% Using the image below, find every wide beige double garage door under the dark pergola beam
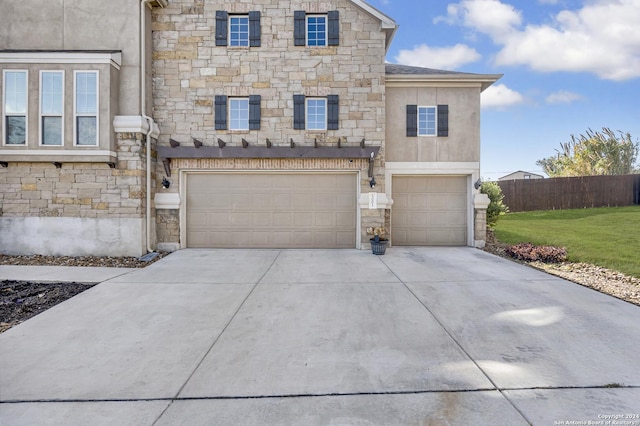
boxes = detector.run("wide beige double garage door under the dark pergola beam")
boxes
[186,173,357,248]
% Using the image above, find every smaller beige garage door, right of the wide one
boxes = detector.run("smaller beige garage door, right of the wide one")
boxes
[391,176,467,246]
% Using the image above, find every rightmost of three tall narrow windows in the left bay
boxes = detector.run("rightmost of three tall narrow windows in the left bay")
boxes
[74,71,98,146]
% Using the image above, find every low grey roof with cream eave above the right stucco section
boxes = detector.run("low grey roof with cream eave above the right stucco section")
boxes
[386,64,502,90]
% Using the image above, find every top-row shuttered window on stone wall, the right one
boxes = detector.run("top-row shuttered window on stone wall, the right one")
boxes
[293,10,340,47]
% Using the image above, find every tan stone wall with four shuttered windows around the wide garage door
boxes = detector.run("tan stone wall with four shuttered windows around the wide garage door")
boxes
[152,0,388,248]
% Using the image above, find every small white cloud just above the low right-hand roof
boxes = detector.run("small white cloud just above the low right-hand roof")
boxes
[395,44,481,70]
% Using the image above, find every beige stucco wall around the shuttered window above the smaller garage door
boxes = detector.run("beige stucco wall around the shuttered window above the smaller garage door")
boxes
[386,85,480,162]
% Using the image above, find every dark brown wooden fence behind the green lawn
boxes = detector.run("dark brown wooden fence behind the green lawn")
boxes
[498,175,640,212]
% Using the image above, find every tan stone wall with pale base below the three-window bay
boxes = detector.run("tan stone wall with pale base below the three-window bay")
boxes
[0,133,146,256]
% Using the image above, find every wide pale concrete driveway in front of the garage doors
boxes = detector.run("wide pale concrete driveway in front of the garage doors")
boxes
[0,247,640,426]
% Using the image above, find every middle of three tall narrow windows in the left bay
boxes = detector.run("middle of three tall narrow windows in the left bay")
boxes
[40,71,64,146]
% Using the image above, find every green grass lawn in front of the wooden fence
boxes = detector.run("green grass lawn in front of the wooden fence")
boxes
[495,206,640,278]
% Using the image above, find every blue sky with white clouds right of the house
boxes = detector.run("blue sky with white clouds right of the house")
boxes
[368,0,640,180]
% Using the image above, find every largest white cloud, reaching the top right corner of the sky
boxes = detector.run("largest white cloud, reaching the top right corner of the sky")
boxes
[441,0,640,81]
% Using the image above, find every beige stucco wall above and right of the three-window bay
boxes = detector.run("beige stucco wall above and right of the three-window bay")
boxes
[0,0,145,115]
